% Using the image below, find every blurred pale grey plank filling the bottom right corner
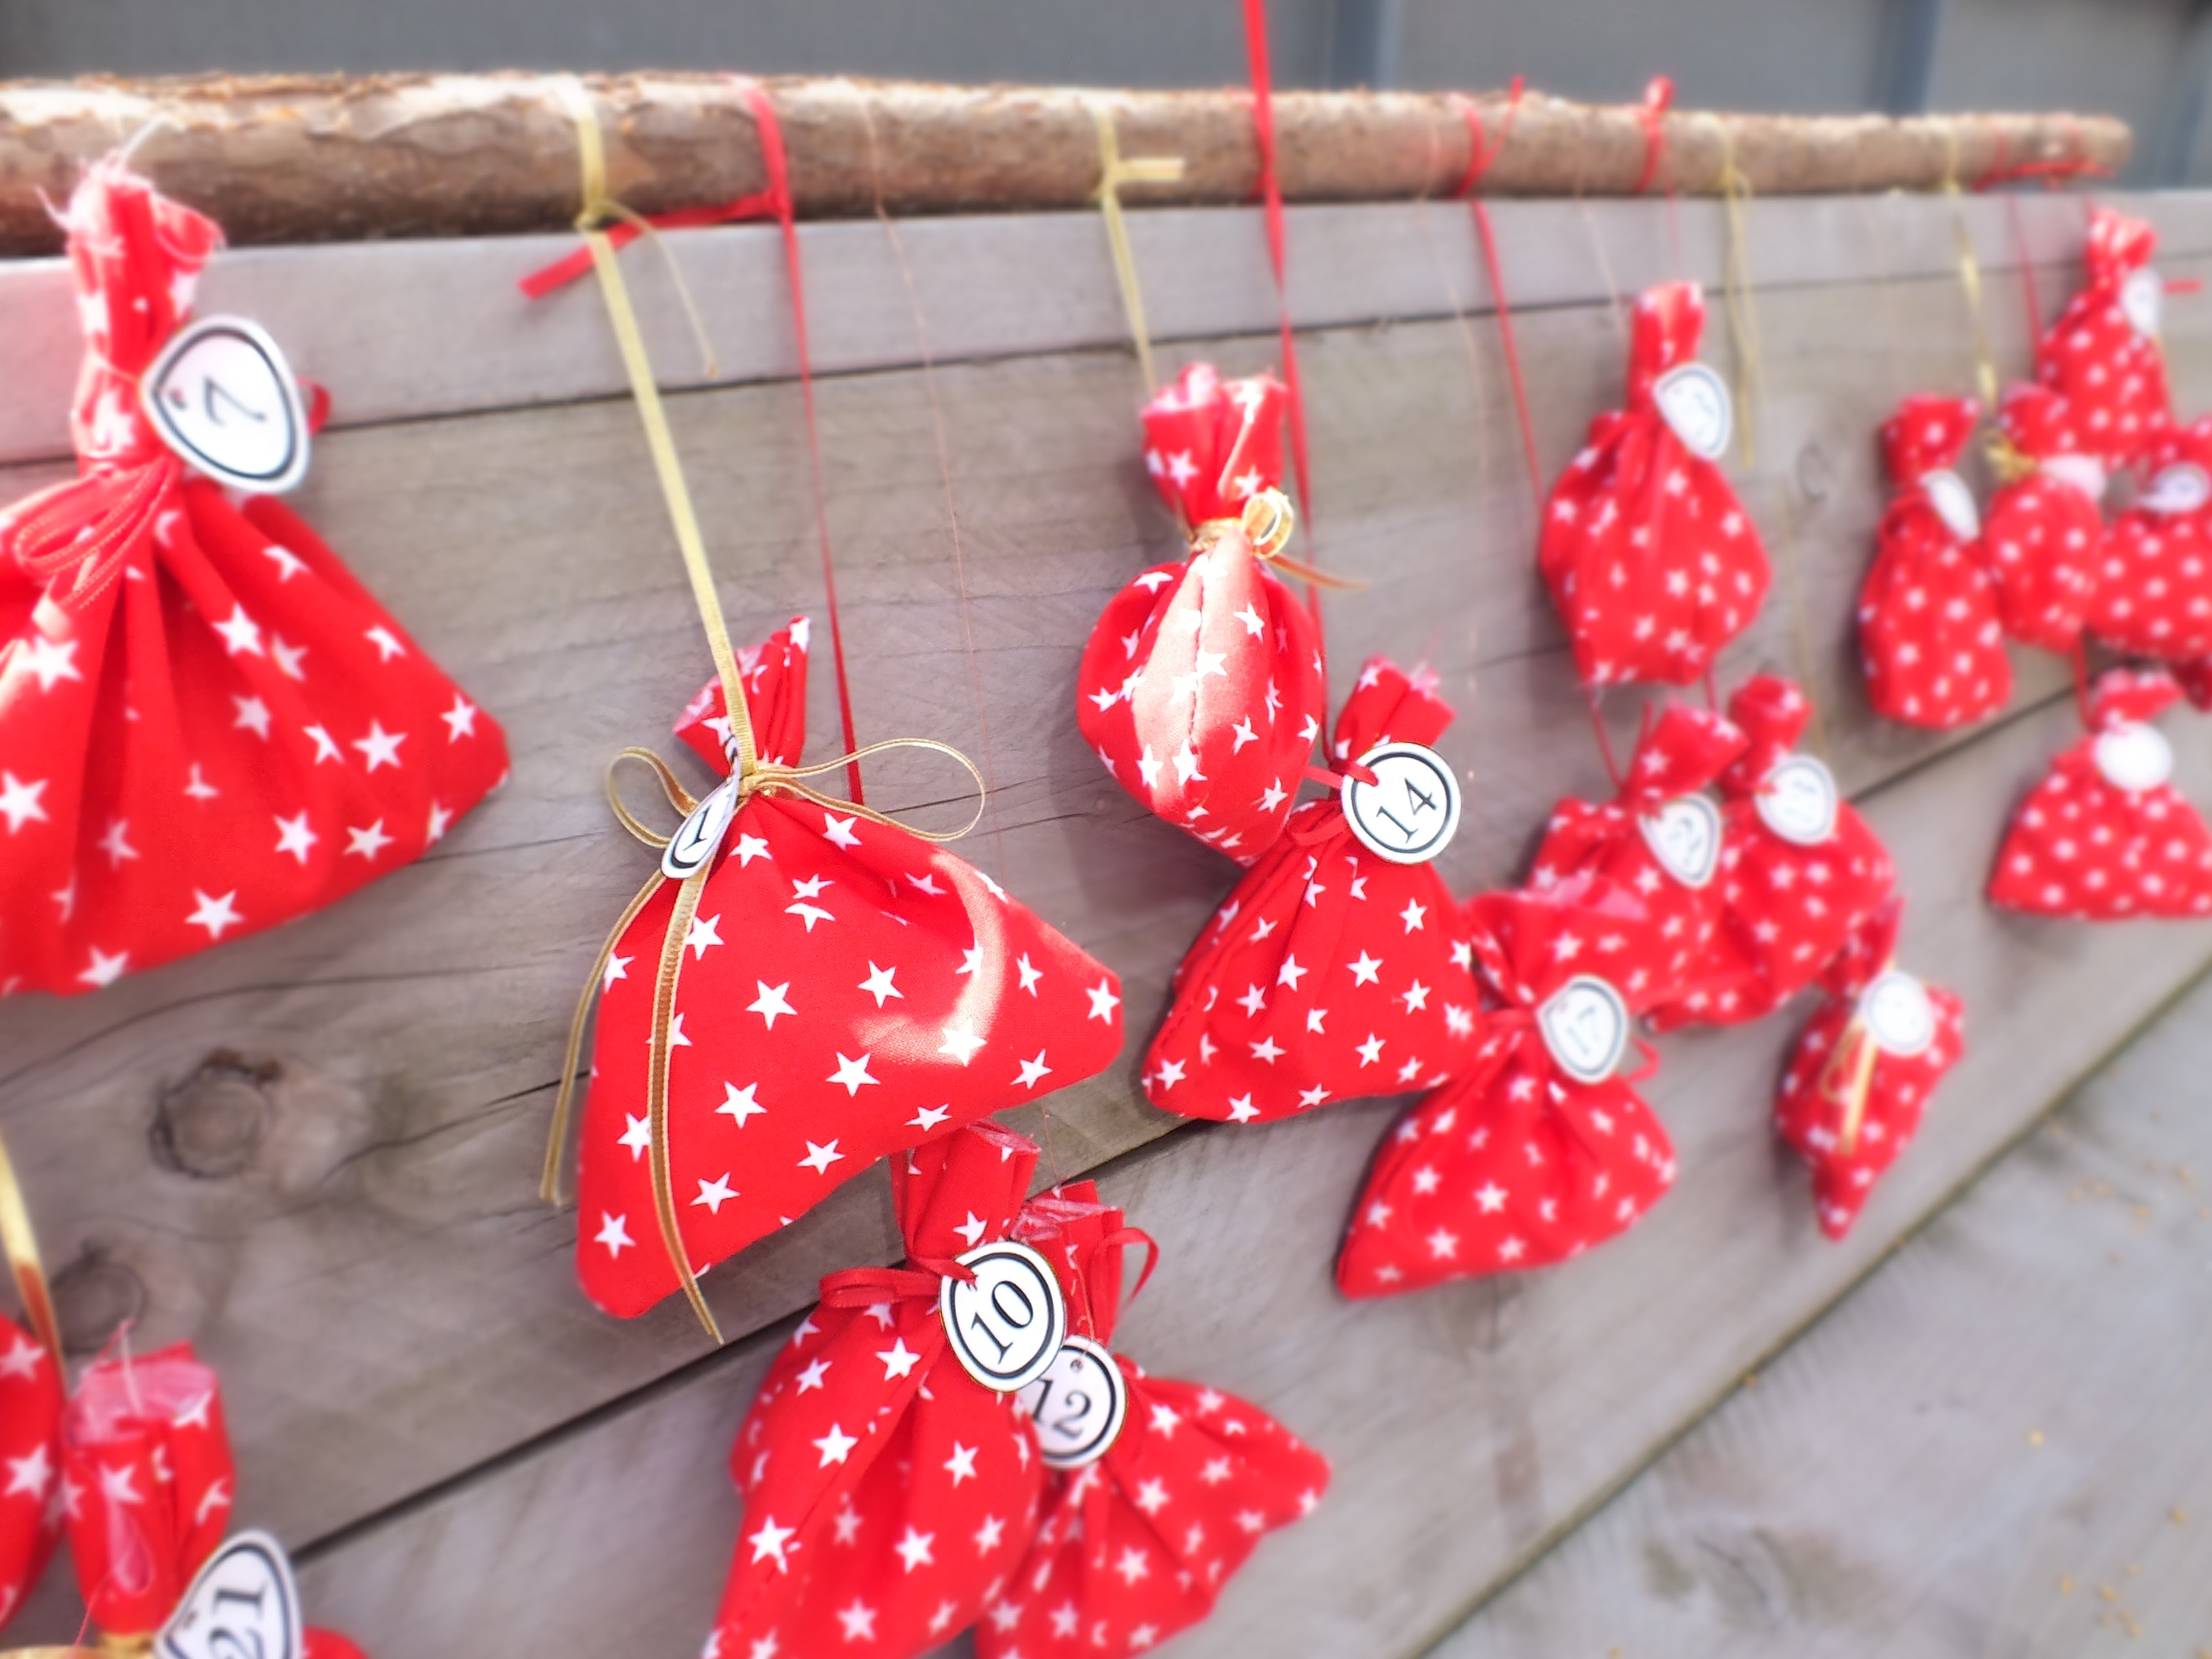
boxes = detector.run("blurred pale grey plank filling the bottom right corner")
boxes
[1435,982,2212,1659]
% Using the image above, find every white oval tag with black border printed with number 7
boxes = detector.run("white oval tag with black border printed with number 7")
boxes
[140,316,308,495]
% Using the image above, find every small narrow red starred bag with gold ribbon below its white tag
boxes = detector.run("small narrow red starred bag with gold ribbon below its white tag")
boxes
[1774,898,1964,1239]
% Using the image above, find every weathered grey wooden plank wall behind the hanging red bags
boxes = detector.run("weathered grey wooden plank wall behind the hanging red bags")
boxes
[13,194,2212,1659]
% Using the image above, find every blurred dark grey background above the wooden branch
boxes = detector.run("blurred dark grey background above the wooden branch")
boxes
[0,0,2212,184]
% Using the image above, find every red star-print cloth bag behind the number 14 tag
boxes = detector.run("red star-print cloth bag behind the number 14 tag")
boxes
[1143,657,1482,1124]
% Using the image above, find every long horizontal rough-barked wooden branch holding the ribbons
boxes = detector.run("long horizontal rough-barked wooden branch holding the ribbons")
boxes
[0,73,2132,254]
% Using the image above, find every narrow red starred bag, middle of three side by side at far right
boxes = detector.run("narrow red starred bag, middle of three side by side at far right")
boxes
[1982,385,2106,653]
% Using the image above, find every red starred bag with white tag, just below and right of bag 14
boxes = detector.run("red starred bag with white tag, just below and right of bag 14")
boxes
[1336,885,1675,1296]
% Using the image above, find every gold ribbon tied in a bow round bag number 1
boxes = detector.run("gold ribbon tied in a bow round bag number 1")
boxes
[539,75,987,1343]
